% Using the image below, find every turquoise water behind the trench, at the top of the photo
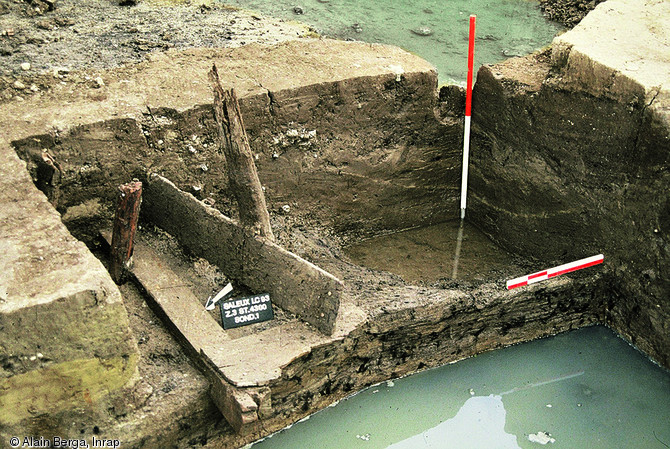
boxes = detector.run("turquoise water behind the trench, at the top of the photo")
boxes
[224,0,562,83]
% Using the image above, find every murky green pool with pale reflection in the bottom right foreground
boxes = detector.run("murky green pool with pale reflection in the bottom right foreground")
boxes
[252,326,670,449]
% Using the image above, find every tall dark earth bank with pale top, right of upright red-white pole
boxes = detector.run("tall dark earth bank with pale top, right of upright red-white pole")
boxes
[472,0,670,367]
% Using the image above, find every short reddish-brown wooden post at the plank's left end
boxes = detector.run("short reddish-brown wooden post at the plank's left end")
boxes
[110,181,142,283]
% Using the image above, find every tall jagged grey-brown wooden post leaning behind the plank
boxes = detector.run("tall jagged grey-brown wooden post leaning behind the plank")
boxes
[209,65,274,241]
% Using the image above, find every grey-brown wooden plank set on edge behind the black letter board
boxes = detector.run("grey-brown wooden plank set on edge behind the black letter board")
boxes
[143,174,344,335]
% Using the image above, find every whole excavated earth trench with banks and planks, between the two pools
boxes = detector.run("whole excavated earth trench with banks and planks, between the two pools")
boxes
[0,0,670,448]
